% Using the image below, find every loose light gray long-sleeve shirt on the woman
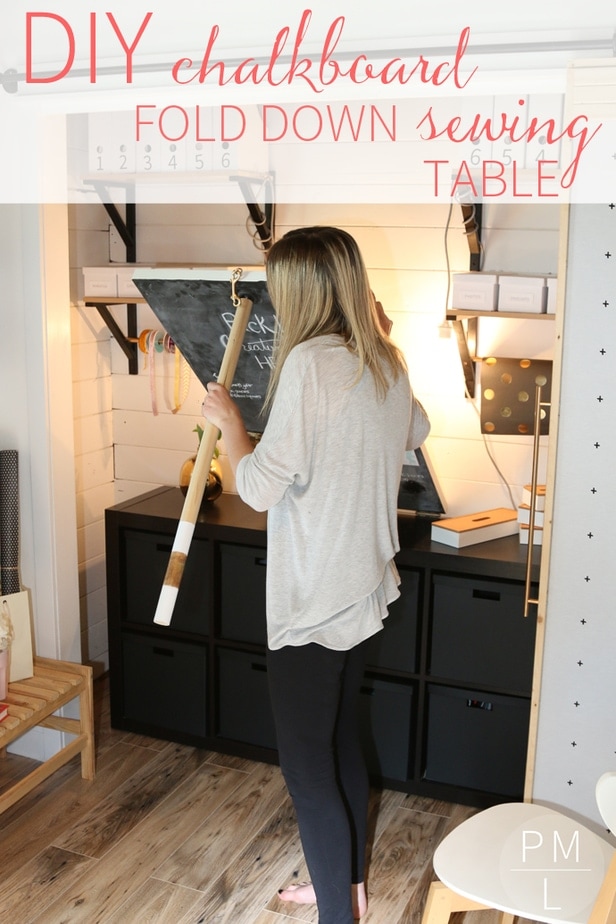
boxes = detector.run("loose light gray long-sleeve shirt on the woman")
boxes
[236,335,430,650]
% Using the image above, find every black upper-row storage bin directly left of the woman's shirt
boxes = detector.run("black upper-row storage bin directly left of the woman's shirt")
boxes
[220,542,267,645]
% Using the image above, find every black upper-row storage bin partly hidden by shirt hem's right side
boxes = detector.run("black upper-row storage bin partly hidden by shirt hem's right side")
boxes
[366,568,419,673]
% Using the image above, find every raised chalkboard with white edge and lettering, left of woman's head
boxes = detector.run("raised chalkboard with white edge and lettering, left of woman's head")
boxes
[133,267,276,433]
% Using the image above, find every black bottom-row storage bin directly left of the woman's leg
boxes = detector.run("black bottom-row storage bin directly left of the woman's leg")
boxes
[218,648,276,748]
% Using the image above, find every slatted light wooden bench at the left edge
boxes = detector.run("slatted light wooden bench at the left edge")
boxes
[0,657,95,814]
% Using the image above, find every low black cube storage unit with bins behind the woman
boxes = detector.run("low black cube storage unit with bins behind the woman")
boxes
[106,488,539,806]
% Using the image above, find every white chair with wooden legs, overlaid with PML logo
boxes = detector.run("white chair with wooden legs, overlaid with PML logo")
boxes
[422,772,616,924]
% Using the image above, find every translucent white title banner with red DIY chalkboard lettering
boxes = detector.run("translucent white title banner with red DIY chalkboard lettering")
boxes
[0,0,616,203]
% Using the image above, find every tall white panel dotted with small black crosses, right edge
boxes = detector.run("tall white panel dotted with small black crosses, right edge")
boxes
[533,200,616,821]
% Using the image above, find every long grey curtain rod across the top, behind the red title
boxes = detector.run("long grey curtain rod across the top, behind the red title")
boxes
[0,32,616,93]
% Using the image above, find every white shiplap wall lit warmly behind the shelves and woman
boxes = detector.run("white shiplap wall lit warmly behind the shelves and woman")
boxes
[71,204,559,664]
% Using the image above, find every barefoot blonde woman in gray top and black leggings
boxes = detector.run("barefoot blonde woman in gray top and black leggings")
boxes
[203,227,430,924]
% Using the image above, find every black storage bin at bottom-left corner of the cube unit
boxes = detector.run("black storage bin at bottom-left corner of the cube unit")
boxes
[122,633,207,738]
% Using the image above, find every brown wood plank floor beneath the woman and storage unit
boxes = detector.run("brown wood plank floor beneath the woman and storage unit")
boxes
[0,679,528,924]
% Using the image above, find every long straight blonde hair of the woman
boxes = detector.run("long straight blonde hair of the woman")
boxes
[265,226,406,406]
